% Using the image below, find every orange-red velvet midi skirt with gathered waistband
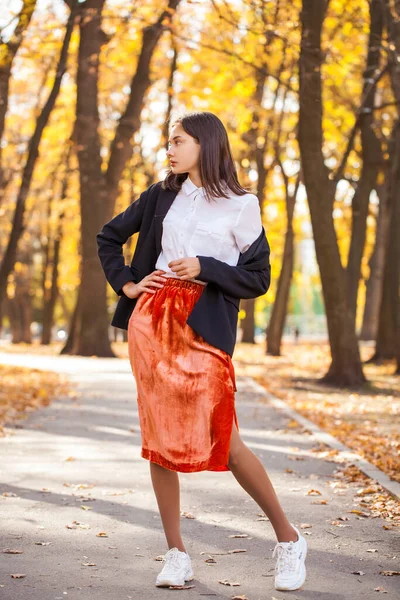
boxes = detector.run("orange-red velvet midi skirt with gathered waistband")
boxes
[128,277,239,473]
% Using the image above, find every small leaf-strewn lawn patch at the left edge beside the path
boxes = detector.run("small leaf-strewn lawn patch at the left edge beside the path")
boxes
[0,365,70,435]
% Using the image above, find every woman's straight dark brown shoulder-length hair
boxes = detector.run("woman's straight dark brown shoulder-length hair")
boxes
[162,111,249,199]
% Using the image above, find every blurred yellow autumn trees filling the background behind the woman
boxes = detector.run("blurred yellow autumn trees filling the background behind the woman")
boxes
[0,0,400,385]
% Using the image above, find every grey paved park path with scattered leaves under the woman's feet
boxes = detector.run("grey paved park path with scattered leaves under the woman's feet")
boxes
[0,353,400,600]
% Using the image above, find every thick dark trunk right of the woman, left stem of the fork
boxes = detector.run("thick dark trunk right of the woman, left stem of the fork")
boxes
[298,0,365,386]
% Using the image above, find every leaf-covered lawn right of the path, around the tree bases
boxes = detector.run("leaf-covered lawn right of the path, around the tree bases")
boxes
[234,342,400,482]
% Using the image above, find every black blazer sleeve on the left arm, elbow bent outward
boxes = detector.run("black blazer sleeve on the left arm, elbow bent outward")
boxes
[96,184,155,296]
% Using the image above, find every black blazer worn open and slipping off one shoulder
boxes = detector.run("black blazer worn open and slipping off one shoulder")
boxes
[96,181,271,356]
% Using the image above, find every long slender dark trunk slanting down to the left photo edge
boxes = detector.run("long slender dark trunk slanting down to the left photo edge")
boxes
[0,5,75,310]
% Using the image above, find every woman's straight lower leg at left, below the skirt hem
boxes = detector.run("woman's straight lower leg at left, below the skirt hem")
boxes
[150,461,186,552]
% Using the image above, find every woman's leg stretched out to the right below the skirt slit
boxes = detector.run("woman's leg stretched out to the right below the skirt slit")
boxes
[228,423,297,542]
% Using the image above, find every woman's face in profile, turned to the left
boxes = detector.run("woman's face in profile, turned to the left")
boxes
[167,123,200,174]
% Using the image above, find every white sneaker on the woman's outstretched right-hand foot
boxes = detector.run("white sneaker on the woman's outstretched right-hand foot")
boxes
[272,523,307,590]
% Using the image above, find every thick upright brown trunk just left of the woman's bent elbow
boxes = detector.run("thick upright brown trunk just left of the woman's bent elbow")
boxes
[70,0,114,356]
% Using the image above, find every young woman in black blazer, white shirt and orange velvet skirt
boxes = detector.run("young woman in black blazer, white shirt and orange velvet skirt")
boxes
[97,112,307,590]
